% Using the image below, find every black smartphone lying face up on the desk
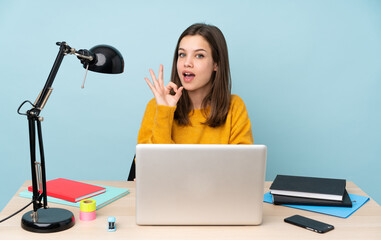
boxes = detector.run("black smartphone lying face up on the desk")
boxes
[284,215,334,233]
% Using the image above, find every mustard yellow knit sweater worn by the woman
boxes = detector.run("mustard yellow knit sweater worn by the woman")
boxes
[138,95,253,144]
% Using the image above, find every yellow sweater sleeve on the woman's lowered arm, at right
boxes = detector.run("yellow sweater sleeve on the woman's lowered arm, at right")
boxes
[229,96,254,144]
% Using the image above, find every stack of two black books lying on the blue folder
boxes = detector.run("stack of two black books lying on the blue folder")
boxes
[270,175,352,207]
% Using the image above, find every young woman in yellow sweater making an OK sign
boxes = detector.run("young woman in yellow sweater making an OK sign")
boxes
[138,24,253,144]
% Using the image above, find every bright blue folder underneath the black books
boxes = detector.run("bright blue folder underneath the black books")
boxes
[263,192,369,218]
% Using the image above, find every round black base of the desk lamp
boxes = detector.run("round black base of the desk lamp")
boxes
[21,208,75,233]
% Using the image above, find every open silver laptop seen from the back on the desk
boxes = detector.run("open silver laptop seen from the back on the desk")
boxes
[136,144,267,225]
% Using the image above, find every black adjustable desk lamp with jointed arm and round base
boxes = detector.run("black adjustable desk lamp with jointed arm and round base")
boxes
[17,42,124,233]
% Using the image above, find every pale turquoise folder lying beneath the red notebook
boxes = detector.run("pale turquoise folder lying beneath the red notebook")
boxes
[19,184,129,210]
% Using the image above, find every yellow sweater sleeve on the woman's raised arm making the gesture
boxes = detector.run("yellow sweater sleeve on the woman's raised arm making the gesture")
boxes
[138,99,176,144]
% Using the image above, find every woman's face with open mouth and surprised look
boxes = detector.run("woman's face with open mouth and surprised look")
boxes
[177,35,217,96]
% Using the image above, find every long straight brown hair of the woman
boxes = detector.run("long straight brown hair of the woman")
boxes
[171,23,231,127]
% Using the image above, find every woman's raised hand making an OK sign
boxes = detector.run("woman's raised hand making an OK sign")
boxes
[144,64,183,107]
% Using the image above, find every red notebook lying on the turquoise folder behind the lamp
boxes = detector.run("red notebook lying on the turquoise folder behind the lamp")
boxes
[28,178,106,202]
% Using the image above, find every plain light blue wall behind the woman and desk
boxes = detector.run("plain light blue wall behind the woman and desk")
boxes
[0,0,381,209]
